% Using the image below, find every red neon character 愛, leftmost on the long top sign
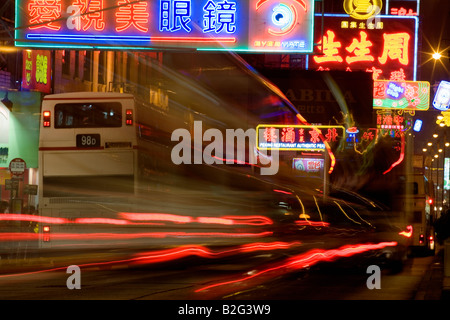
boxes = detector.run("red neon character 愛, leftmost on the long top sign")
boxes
[28,0,61,30]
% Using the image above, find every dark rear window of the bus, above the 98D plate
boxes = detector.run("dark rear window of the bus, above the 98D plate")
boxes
[55,102,122,128]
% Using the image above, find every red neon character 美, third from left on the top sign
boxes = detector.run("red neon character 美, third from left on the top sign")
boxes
[116,0,149,32]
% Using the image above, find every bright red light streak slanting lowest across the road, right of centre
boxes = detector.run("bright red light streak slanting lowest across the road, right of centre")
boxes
[195,241,397,292]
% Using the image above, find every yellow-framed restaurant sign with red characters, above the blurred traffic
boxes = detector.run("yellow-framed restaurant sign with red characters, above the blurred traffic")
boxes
[256,124,345,151]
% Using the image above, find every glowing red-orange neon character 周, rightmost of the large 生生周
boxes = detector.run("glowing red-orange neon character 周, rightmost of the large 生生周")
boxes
[378,32,411,65]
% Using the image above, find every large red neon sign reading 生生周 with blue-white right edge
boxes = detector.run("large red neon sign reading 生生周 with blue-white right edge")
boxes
[308,14,418,81]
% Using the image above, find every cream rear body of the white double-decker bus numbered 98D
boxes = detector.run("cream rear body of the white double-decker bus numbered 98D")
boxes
[39,92,137,248]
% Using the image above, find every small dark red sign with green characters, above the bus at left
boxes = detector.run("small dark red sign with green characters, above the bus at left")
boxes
[22,50,52,93]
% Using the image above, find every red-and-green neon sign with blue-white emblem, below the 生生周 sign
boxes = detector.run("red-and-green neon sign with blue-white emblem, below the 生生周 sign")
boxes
[373,80,430,111]
